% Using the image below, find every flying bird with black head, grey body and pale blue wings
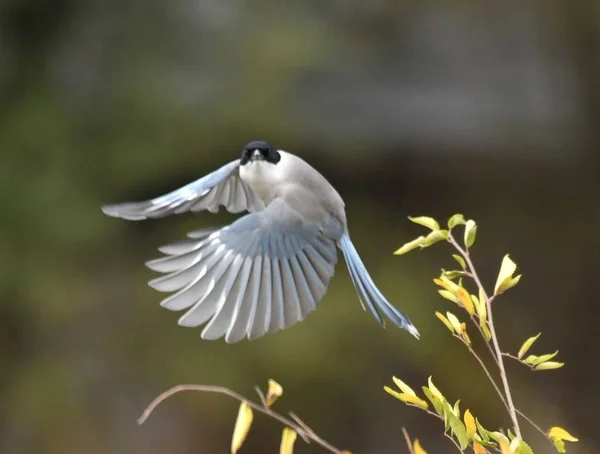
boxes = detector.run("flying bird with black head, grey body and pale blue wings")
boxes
[102,140,419,343]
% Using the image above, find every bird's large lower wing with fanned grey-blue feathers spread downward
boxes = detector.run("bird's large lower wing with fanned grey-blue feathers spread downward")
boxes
[147,200,337,343]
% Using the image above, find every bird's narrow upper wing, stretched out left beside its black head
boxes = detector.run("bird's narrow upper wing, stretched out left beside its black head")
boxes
[102,159,265,221]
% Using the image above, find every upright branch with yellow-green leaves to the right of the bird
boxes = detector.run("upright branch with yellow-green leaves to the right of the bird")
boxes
[384,214,578,454]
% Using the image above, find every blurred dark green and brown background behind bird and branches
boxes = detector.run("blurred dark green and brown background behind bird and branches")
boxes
[0,0,600,454]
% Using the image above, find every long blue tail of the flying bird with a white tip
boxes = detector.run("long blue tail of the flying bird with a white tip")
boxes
[339,233,419,339]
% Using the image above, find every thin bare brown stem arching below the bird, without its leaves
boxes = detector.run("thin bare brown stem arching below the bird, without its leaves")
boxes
[138,385,343,454]
